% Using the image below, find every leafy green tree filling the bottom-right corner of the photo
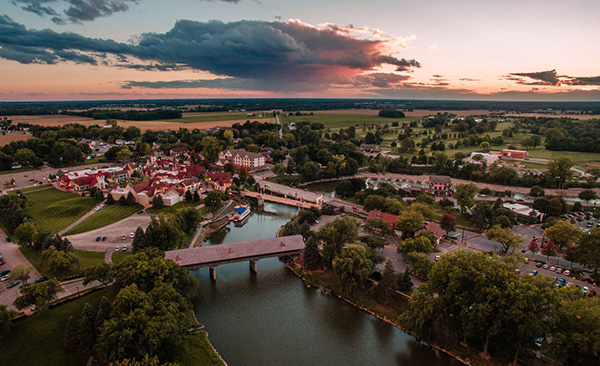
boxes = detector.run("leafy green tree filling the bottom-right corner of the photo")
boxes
[550,298,600,366]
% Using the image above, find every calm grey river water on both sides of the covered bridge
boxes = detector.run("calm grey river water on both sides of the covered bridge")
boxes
[192,203,461,366]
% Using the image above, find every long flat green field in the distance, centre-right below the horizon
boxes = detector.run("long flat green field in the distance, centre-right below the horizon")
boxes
[279,113,419,130]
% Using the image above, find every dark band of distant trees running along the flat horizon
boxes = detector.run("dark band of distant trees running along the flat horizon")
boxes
[0,98,600,116]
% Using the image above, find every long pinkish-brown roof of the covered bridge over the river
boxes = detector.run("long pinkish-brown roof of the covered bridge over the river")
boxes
[165,235,304,267]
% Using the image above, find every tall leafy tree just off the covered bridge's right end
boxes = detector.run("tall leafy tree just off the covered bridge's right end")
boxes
[317,216,358,268]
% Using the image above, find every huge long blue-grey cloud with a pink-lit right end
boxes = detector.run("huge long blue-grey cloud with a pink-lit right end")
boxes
[0,16,420,88]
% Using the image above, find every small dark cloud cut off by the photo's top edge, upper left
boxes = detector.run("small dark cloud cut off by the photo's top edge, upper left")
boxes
[12,0,138,24]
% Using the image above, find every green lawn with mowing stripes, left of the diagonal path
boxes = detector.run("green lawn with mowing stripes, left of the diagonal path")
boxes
[17,187,98,233]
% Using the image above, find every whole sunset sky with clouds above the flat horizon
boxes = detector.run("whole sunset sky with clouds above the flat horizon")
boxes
[0,0,600,101]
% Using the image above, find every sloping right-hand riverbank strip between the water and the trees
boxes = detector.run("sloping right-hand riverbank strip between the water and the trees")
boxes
[286,260,505,366]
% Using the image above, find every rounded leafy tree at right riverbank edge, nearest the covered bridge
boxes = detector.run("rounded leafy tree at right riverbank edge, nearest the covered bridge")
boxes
[333,244,373,296]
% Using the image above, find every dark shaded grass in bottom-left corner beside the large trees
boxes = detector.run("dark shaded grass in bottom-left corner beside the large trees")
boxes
[0,288,115,366]
